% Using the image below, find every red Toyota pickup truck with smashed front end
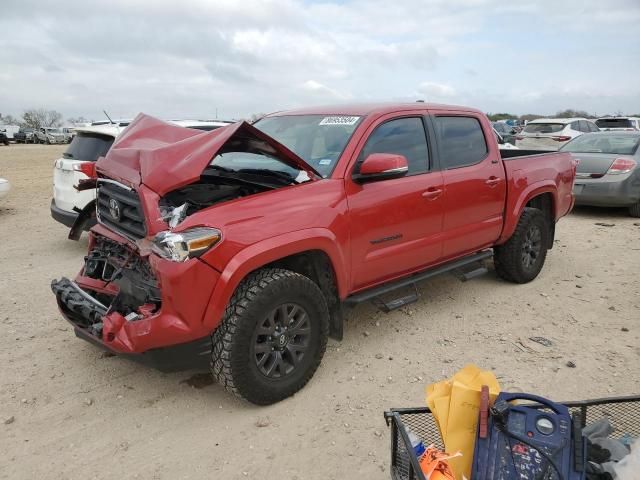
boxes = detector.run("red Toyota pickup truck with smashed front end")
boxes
[52,103,576,404]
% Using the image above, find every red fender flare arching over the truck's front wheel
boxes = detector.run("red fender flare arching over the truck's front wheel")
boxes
[203,228,349,331]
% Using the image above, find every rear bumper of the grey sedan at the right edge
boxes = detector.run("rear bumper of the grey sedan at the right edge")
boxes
[573,175,640,207]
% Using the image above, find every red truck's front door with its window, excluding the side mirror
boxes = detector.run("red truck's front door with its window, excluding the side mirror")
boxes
[345,113,443,290]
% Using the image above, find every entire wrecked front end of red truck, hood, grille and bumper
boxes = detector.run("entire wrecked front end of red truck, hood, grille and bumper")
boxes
[51,115,321,370]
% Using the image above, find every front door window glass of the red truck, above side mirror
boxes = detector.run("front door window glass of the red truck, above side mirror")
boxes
[356,117,429,175]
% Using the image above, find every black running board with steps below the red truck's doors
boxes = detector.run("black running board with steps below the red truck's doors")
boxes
[344,250,493,311]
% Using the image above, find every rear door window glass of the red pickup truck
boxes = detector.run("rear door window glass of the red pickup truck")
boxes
[434,117,489,169]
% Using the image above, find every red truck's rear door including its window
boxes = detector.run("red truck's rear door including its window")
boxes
[431,111,506,259]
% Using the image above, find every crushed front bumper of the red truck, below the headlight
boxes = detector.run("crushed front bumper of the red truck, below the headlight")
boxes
[51,226,219,371]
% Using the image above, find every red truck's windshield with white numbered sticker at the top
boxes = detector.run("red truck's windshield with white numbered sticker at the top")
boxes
[253,115,362,178]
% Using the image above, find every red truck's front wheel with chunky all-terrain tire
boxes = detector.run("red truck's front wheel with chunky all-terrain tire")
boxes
[211,268,329,405]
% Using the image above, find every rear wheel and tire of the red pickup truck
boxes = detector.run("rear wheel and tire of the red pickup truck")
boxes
[493,208,549,283]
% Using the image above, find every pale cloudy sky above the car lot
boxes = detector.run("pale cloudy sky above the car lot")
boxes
[0,0,640,118]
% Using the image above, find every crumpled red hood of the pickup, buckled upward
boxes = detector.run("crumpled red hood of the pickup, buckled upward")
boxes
[96,113,321,195]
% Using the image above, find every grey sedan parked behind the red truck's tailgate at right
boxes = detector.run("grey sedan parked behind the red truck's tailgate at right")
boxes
[560,131,640,217]
